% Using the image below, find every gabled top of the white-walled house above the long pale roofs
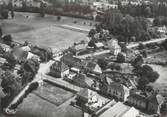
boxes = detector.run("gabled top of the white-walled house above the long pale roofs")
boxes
[77,88,96,99]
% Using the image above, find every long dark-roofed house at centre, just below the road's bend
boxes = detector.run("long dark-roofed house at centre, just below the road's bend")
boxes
[60,54,85,69]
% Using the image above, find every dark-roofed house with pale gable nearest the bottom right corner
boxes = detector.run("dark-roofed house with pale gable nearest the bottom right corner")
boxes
[148,94,164,114]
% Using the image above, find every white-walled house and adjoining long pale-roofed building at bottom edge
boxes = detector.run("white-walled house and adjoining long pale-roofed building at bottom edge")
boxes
[75,89,145,117]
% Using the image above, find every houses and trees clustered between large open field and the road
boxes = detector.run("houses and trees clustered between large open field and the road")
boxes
[68,31,121,56]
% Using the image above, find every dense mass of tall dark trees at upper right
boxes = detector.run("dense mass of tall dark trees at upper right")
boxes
[97,9,151,42]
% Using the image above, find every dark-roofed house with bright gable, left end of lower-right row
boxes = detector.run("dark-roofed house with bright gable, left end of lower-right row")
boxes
[107,82,129,101]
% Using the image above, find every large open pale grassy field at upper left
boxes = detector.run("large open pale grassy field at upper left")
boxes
[0,13,95,49]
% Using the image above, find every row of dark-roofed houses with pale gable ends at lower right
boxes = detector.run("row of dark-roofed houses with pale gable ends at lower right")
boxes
[101,82,165,114]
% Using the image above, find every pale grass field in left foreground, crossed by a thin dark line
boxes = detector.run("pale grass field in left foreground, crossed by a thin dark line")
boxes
[11,84,82,117]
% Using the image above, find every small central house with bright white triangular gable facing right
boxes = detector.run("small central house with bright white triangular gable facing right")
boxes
[85,62,102,74]
